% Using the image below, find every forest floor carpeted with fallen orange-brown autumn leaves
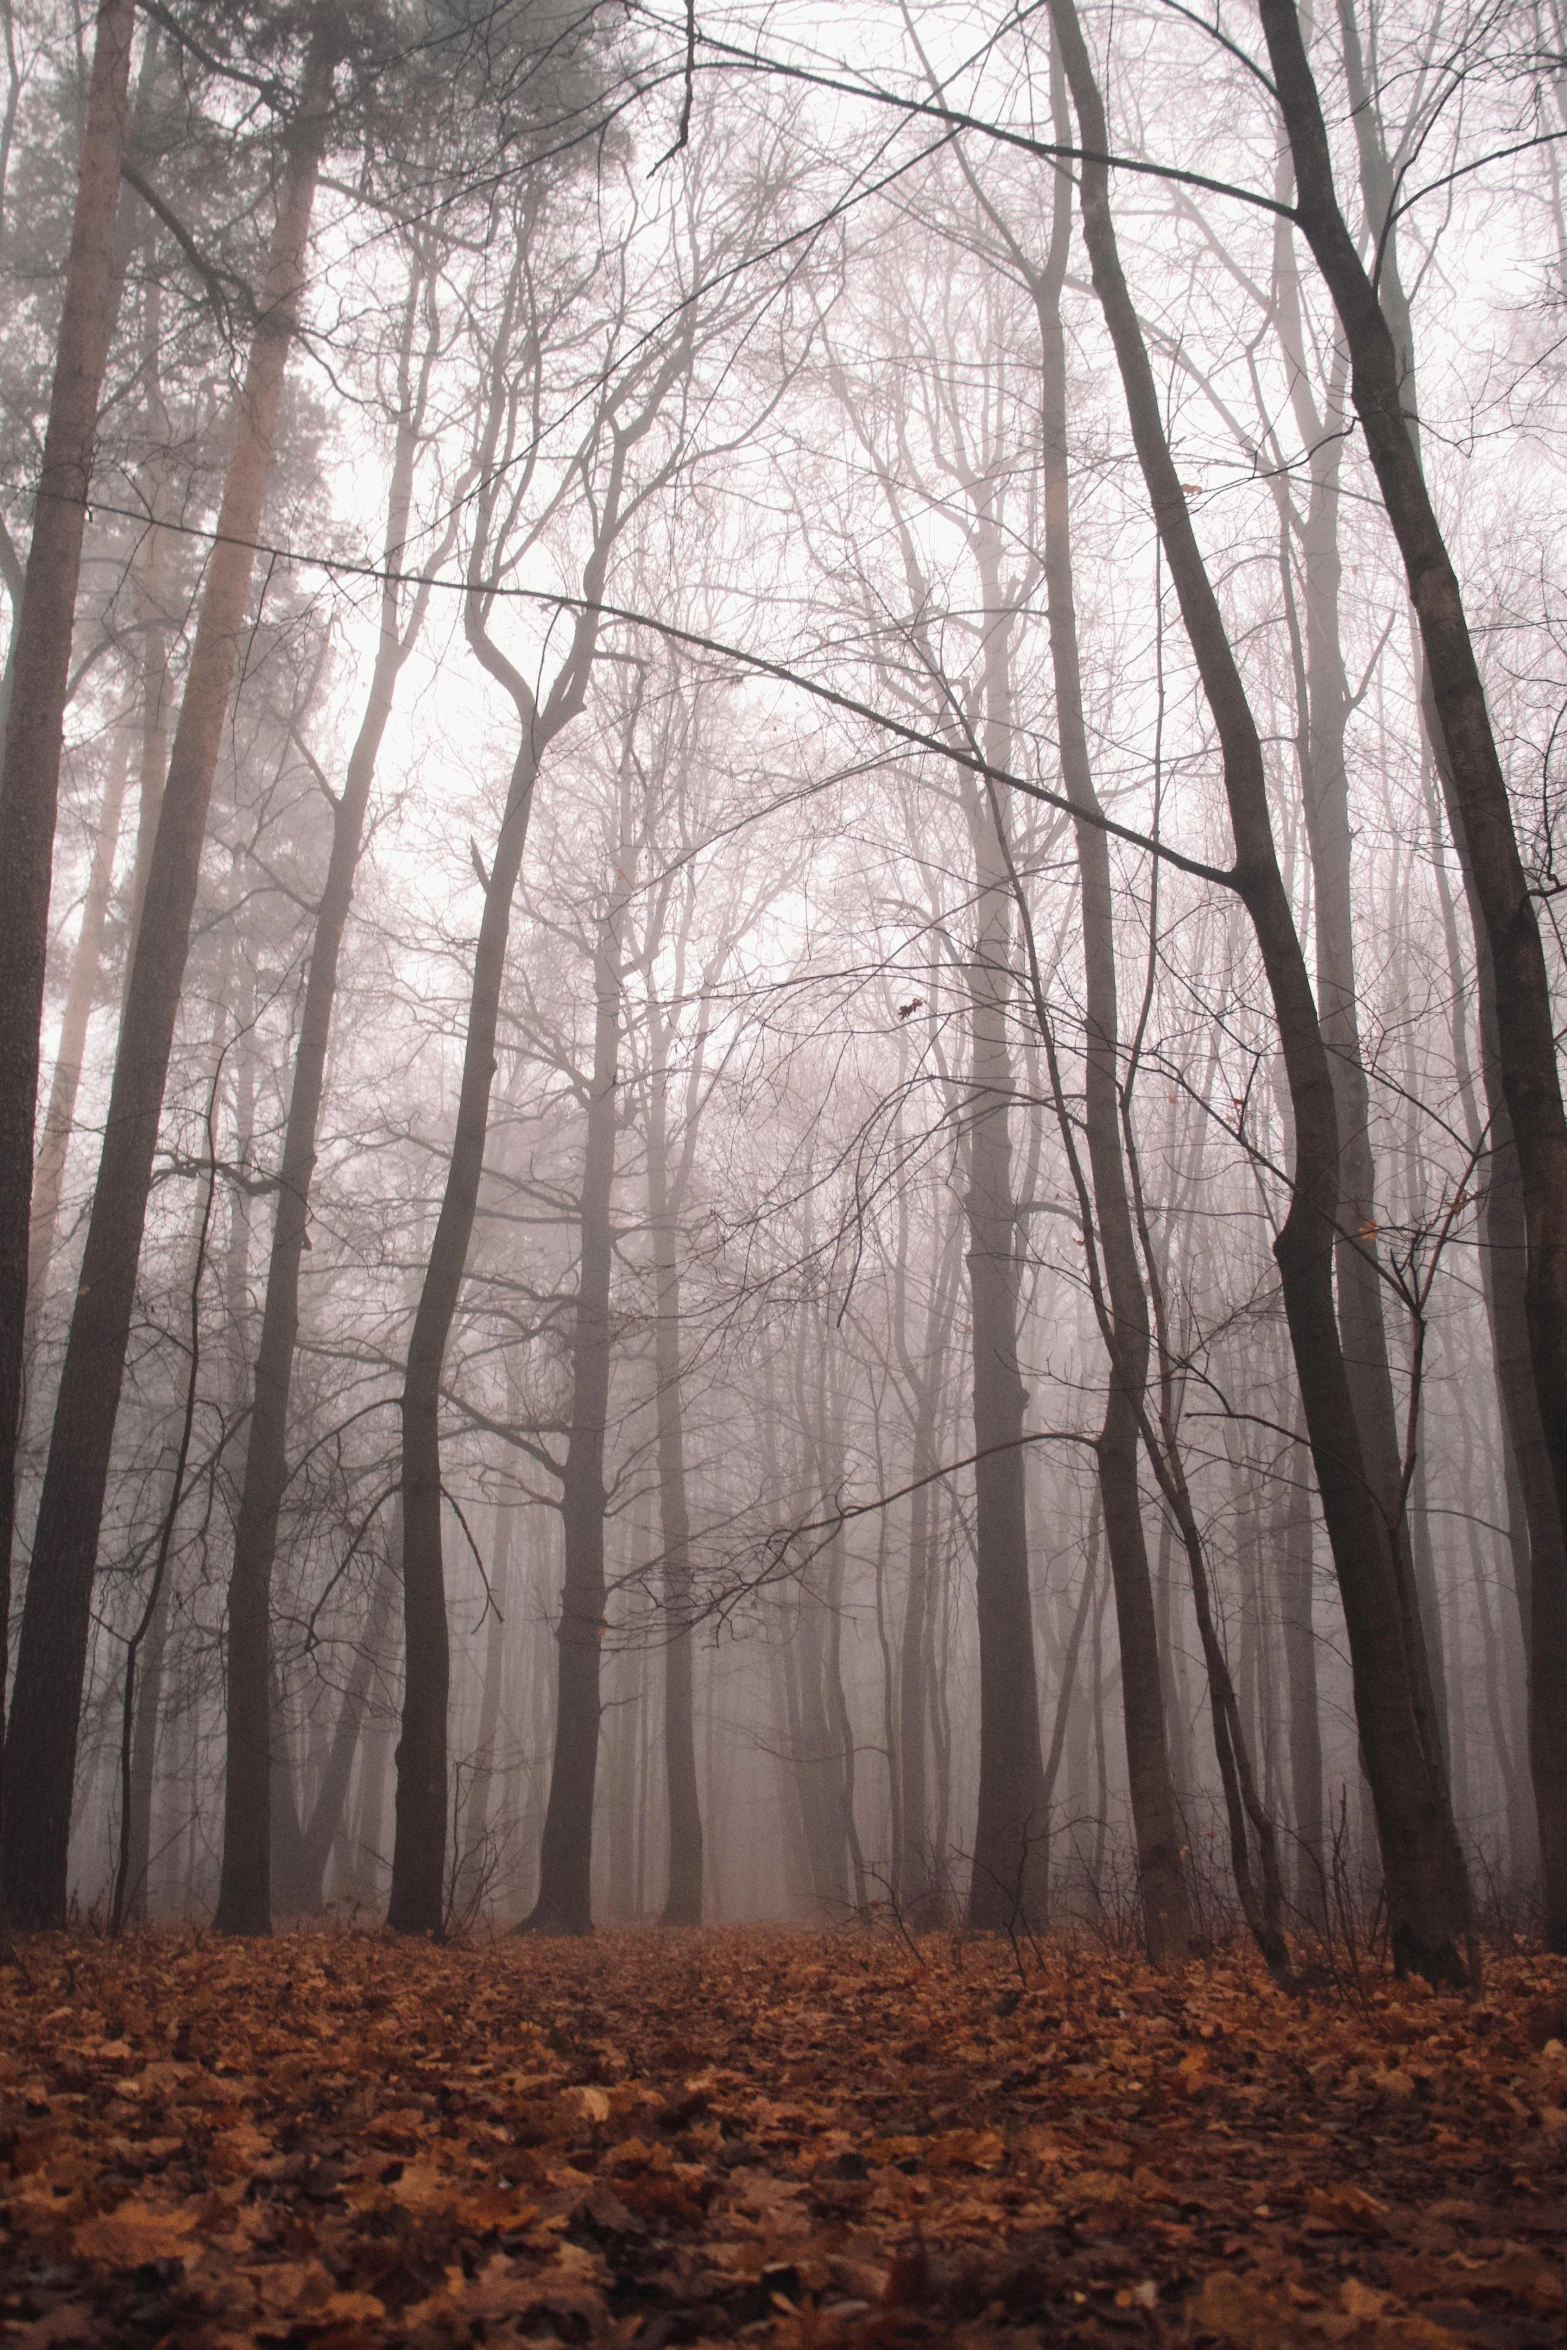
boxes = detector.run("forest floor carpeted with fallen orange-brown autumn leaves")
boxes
[0,1927,1567,2350]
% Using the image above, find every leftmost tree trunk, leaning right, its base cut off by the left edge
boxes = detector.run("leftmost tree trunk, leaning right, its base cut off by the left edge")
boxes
[0,0,136,1776]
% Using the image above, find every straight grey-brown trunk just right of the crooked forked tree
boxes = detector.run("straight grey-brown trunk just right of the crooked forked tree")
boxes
[524,845,632,1934]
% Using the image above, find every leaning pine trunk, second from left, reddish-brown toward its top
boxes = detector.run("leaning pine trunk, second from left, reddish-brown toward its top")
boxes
[5,32,341,1927]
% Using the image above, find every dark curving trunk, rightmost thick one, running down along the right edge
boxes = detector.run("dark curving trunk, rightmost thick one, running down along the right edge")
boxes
[1259,0,1567,1951]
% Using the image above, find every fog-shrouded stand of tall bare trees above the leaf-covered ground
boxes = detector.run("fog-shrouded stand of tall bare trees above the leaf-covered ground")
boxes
[0,0,1567,1981]
